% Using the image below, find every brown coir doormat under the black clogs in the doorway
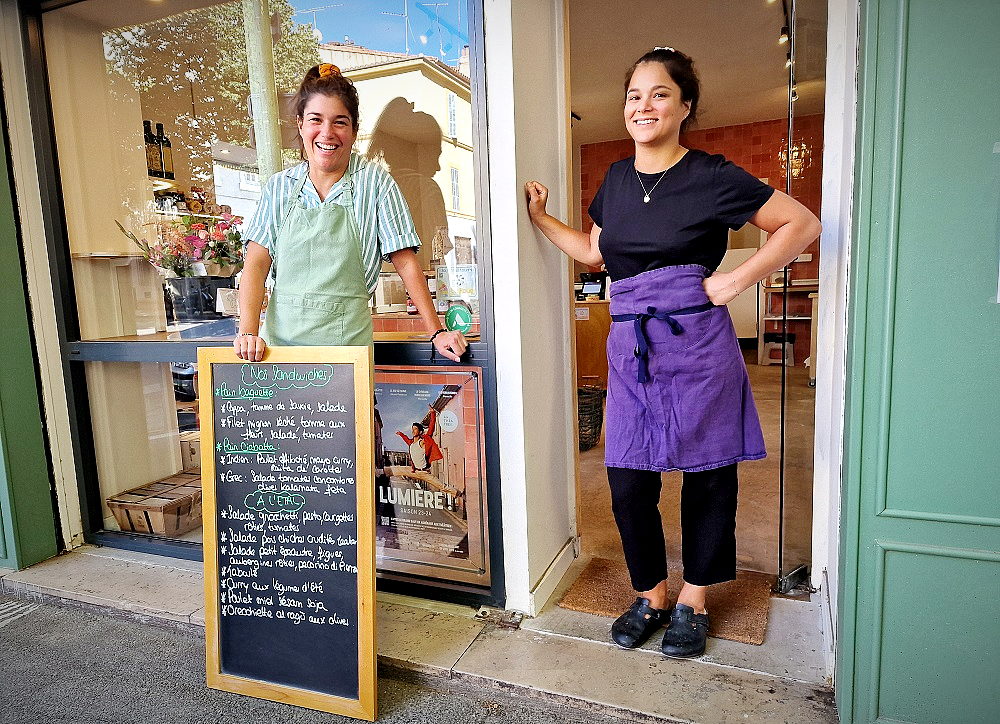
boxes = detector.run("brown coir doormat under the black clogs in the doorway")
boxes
[559,558,775,646]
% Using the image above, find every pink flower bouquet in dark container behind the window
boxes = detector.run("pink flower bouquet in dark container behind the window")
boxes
[115,214,243,321]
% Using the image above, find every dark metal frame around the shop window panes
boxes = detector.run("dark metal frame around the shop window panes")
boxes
[21,0,506,607]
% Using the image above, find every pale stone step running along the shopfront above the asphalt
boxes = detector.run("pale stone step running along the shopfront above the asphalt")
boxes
[0,546,837,724]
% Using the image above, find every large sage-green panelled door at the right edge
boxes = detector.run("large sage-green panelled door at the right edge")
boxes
[837,0,1000,724]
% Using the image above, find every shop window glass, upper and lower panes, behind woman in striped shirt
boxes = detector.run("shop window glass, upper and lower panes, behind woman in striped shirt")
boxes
[43,0,482,552]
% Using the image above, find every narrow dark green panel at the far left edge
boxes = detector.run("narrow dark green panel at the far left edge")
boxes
[0,79,61,569]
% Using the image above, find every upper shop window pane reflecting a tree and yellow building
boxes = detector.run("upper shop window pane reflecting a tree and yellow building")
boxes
[57,0,482,346]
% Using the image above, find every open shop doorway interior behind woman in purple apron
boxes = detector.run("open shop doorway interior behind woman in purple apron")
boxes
[569,0,827,680]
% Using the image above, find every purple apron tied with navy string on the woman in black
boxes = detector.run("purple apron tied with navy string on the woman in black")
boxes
[605,264,766,472]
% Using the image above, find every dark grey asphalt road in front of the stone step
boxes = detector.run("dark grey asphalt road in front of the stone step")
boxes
[0,595,636,724]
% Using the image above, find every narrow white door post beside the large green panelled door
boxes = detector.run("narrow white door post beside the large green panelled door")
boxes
[812,0,858,672]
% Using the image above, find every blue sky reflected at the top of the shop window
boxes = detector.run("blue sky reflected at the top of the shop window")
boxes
[290,0,469,65]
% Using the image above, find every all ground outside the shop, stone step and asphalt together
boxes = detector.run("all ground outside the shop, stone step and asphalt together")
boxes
[0,546,838,724]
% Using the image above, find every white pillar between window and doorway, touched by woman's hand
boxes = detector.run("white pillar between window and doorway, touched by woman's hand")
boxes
[484,0,576,614]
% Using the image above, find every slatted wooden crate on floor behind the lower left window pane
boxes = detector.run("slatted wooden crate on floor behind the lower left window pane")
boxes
[108,470,201,536]
